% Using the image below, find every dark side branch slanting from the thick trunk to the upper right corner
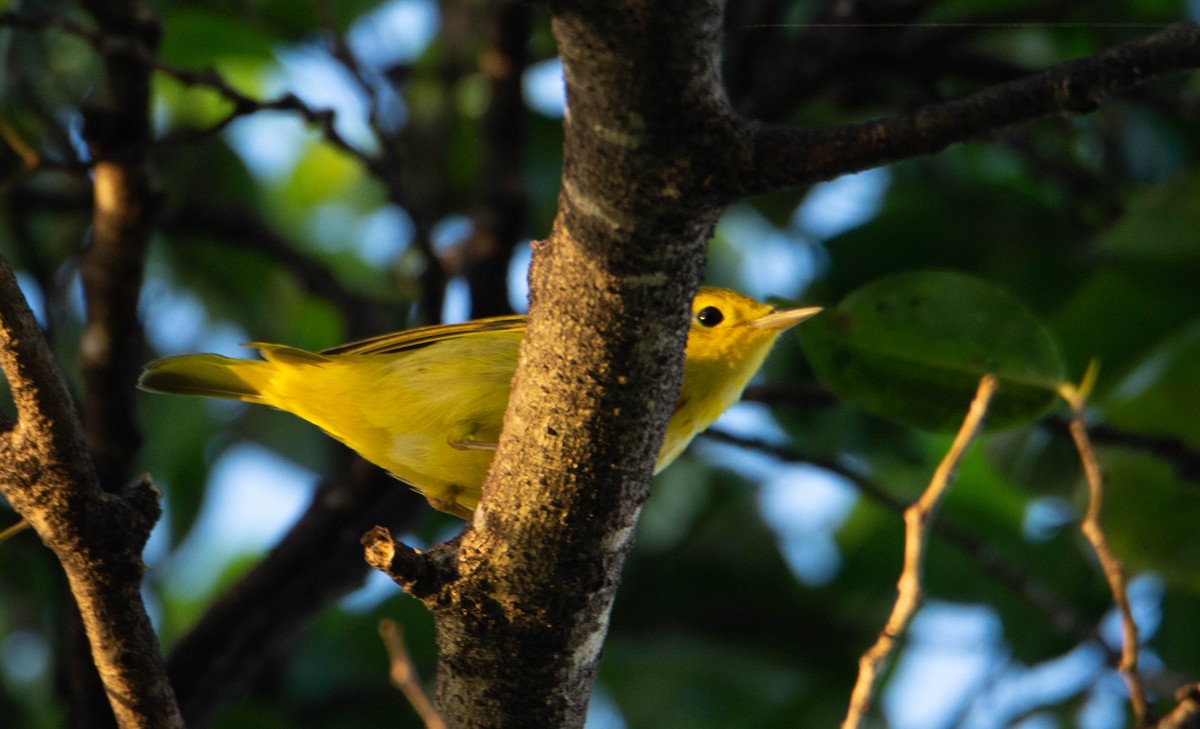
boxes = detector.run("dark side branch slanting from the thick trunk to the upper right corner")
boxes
[727,23,1200,198]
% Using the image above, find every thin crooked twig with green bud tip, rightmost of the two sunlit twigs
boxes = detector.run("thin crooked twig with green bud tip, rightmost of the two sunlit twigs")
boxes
[1062,378,1148,727]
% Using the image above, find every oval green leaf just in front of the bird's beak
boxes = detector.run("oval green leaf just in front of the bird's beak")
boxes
[800,271,1063,430]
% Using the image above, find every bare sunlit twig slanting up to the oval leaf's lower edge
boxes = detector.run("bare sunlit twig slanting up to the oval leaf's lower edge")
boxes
[841,374,996,729]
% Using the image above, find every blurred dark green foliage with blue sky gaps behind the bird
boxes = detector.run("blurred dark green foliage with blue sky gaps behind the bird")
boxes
[0,0,1200,729]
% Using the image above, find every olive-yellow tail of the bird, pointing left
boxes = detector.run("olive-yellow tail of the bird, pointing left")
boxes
[138,355,275,403]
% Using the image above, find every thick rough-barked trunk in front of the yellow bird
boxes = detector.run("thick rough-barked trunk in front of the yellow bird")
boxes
[415,0,737,727]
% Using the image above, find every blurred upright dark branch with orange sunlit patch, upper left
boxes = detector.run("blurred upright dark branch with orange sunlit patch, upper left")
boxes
[80,0,161,492]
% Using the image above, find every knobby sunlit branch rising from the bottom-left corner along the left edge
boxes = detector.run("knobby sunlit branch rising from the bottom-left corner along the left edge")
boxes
[0,255,184,729]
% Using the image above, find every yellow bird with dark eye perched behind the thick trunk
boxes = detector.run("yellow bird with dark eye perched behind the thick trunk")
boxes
[138,287,821,518]
